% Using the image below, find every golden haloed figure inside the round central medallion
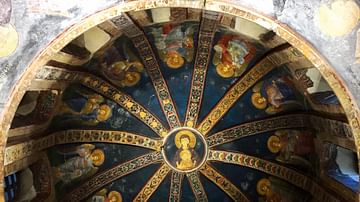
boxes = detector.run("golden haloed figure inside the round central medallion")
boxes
[175,130,197,170]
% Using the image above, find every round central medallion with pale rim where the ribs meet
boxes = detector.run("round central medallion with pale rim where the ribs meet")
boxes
[162,127,208,172]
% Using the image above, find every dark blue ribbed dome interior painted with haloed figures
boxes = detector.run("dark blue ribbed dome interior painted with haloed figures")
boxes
[9,7,358,201]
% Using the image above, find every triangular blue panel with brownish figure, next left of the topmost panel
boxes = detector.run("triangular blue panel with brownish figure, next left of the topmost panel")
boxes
[85,36,166,122]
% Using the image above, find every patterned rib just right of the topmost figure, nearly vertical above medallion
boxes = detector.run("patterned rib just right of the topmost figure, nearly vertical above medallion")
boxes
[184,11,221,127]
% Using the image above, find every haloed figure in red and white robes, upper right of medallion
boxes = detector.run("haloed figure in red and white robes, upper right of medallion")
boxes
[213,34,256,78]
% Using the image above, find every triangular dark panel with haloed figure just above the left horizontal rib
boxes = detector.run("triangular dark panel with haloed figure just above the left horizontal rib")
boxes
[51,85,161,137]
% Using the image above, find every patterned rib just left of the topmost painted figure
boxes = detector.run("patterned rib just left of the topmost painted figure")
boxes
[112,13,181,128]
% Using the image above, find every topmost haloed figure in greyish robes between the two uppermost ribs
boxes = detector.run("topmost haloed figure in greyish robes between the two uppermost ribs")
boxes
[151,24,195,69]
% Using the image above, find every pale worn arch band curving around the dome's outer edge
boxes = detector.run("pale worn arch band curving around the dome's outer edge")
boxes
[0,0,360,201]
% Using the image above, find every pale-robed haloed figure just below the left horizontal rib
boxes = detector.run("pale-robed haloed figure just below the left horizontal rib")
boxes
[53,144,105,184]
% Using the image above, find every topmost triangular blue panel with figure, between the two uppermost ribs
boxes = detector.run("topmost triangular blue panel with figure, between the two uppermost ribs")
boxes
[144,21,199,120]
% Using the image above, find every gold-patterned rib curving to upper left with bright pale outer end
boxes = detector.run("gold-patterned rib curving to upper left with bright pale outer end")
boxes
[36,66,168,137]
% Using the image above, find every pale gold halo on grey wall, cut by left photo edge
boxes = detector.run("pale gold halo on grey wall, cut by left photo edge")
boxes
[0,24,19,57]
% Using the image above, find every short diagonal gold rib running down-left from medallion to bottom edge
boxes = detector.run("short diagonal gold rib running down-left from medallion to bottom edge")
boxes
[133,164,170,202]
